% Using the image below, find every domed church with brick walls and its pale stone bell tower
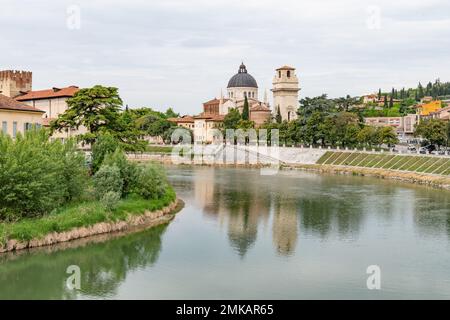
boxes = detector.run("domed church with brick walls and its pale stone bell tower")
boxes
[169,63,300,142]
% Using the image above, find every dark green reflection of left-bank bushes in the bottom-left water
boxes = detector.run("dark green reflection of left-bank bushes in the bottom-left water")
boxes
[0,225,167,299]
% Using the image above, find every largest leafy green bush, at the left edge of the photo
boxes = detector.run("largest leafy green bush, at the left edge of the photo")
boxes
[0,129,87,220]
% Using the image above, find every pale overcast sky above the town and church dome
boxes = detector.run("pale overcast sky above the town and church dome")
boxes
[0,0,450,114]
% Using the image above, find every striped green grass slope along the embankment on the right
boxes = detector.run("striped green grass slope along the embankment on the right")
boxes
[317,151,450,175]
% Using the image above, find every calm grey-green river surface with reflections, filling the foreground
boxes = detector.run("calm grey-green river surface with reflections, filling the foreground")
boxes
[0,167,450,299]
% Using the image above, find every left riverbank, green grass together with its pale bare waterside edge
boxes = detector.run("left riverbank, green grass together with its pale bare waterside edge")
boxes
[0,190,184,253]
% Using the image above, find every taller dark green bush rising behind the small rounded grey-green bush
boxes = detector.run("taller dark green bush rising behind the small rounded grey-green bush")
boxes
[102,148,138,197]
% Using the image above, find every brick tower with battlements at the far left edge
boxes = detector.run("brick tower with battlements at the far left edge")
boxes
[0,70,32,98]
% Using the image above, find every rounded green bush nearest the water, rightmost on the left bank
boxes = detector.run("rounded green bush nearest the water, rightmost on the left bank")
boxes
[133,163,170,199]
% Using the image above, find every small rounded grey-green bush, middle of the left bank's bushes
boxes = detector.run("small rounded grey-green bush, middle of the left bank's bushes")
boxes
[94,165,123,200]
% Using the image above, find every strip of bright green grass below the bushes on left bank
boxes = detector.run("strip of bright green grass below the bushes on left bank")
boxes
[0,188,176,244]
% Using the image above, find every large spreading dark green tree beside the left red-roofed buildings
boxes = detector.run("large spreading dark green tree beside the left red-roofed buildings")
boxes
[51,85,123,143]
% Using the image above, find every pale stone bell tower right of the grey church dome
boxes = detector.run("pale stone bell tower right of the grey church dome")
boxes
[272,66,300,121]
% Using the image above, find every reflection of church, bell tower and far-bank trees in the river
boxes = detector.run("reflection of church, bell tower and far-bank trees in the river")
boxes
[172,168,450,257]
